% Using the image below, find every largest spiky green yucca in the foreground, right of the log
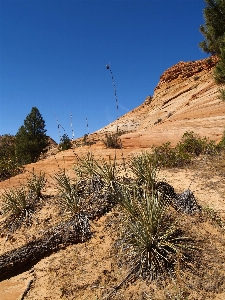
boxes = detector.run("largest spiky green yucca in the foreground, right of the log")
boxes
[119,187,194,279]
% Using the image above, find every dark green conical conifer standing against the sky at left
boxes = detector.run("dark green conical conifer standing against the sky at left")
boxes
[16,107,48,164]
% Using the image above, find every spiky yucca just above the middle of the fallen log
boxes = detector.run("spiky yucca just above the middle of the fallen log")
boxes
[54,170,81,215]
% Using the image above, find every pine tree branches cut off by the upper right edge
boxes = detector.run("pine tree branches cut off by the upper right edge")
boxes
[199,0,225,100]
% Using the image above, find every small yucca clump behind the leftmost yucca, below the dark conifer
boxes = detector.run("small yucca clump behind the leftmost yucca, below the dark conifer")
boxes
[27,172,47,199]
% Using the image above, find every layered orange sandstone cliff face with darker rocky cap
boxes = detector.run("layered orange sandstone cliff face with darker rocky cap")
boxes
[98,57,225,148]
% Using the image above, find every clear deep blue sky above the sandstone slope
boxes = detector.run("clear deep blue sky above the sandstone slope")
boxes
[0,0,207,142]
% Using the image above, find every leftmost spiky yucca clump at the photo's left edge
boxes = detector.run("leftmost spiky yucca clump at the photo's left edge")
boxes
[1,187,35,231]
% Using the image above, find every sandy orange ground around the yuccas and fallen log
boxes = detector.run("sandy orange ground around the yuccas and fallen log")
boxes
[0,148,225,300]
